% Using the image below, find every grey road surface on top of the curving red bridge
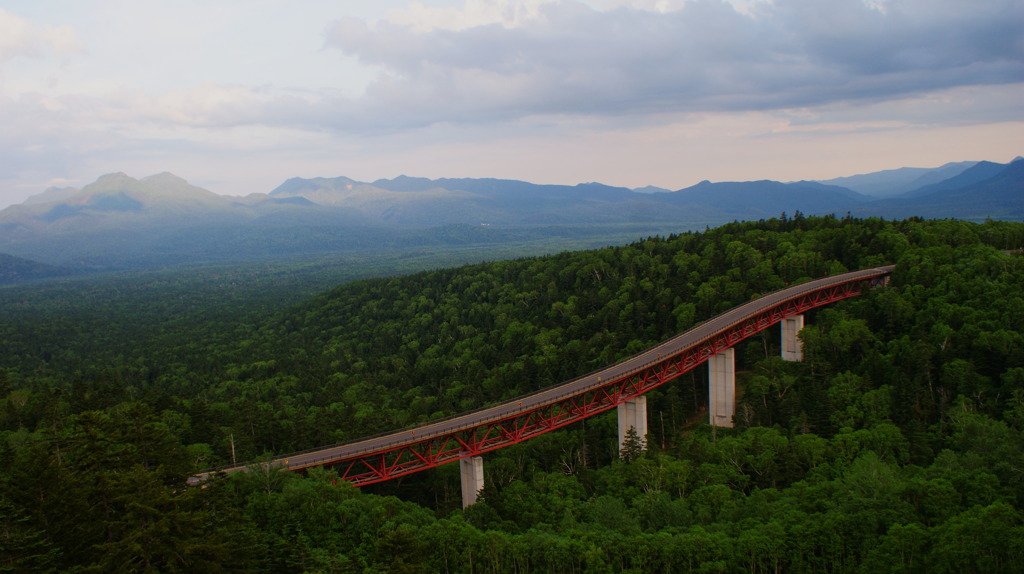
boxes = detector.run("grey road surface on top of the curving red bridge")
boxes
[188,265,895,484]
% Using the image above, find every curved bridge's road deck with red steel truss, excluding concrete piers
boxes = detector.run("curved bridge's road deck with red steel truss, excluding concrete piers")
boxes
[189,265,894,485]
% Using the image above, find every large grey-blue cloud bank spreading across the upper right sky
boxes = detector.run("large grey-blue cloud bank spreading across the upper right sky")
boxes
[328,0,1024,125]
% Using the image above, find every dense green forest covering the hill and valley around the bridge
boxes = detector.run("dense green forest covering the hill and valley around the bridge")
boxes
[0,214,1024,573]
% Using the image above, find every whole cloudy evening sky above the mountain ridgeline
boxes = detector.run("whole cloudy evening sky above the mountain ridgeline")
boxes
[0,0,1024,208]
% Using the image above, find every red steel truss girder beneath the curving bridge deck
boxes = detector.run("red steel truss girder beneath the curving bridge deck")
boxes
[327,276,872,485]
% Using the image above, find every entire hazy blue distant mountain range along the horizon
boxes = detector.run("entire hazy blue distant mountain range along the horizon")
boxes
[0,159,1024,274]
